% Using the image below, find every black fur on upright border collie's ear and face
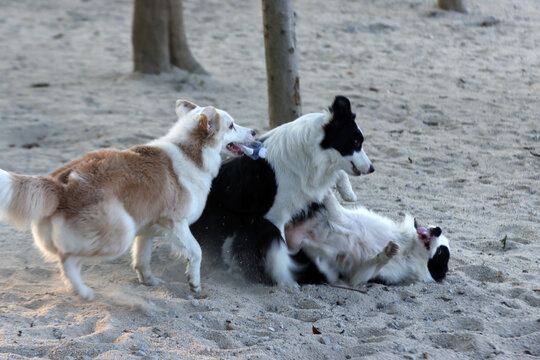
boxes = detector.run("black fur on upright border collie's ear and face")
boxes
[321,96,364,156]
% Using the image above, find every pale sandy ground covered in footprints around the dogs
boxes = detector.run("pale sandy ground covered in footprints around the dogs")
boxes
[0,0,540,359]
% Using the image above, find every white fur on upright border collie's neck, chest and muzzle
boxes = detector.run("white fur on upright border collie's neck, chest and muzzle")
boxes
[250,112,371,286]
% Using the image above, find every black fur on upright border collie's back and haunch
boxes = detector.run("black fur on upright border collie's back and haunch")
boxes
[190,156,283,283]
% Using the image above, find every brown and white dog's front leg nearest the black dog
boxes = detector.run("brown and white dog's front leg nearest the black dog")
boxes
[172,219,202,292]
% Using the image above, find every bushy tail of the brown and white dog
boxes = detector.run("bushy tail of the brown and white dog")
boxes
[0,169,60,229]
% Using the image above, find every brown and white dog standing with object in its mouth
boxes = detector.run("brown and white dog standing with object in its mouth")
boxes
[0,100,255,300]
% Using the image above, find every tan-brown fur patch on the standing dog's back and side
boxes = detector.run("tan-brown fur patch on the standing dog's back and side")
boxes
[51,146,190,225]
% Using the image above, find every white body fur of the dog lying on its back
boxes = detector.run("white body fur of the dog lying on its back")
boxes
[287,193,448,286]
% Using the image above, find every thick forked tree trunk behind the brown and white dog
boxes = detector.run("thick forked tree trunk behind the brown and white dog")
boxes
[132,0,206,74]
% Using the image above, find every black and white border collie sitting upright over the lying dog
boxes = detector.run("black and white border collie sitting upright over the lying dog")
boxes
[191,96,375,287]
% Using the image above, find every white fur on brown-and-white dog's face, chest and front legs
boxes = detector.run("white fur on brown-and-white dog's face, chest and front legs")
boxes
[132,105,254,292]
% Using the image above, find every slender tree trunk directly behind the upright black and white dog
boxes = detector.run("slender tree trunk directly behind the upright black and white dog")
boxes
[262,0,302,128]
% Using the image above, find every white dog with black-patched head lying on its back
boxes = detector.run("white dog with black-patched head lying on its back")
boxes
[285,184,450,286]
